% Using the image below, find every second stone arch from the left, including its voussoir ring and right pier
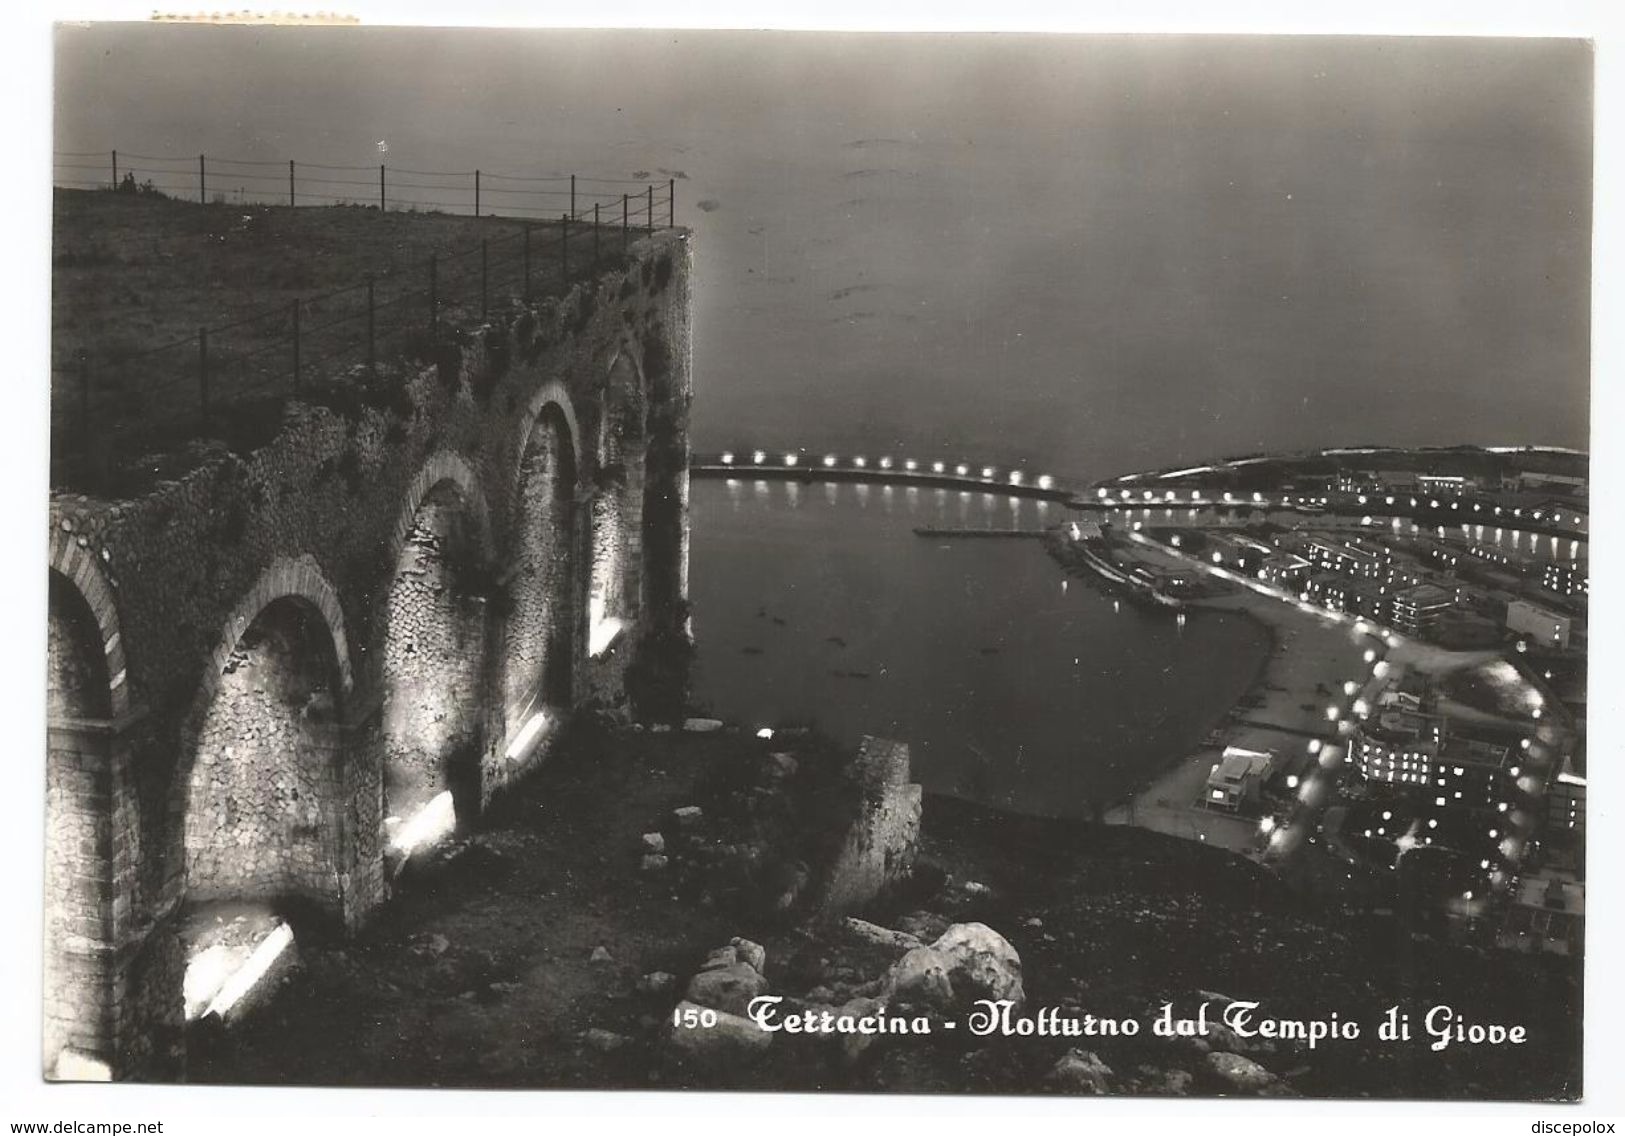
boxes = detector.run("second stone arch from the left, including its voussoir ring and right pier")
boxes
[166,554,367,968]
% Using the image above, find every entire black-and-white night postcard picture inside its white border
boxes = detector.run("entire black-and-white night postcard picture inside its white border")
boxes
[44,23,1597,1102]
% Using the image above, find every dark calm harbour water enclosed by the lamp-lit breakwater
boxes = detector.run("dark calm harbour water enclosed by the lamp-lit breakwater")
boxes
[691,479,1269,816]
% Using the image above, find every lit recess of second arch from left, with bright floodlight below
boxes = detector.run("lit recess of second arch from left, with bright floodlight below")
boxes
[180,596,346,1019]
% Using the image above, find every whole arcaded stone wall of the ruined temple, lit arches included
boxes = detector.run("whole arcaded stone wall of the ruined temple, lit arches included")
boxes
[44,225,691,1077]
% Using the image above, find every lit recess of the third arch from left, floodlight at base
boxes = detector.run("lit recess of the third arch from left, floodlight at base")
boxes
[382,481,486,855]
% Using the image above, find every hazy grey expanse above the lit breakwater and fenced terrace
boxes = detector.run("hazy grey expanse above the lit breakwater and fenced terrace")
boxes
[57,24,1593,476]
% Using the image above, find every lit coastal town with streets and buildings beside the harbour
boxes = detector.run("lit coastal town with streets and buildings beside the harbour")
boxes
[1050,449,1588,956]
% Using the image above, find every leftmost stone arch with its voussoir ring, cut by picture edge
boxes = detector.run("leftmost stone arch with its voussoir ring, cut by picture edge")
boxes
[44,565,122,1077]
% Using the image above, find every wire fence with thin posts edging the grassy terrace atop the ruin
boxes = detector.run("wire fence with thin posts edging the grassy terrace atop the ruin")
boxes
[52,153,676,484]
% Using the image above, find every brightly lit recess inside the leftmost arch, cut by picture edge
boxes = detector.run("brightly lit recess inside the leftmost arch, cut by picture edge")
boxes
[44,572,114,1077]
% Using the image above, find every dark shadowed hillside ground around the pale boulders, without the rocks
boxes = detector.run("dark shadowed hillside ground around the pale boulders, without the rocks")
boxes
[192,718,1580,1099]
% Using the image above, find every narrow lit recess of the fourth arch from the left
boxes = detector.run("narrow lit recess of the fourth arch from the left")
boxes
[505,403,577,762]
